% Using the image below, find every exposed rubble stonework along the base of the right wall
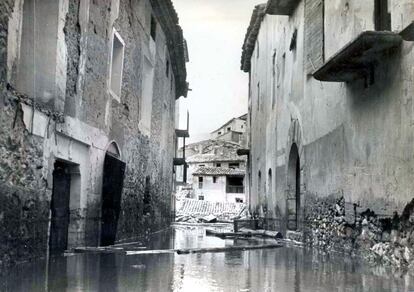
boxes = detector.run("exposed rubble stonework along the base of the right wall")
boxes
[304,197,414,268]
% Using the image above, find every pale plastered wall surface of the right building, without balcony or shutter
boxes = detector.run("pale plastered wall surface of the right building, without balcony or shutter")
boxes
[243,0,414,266]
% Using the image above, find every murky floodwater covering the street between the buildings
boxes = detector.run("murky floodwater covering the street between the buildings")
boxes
[0,227,414,292]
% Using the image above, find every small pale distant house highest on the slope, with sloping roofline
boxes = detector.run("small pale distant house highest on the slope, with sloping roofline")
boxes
[210,114,247,144]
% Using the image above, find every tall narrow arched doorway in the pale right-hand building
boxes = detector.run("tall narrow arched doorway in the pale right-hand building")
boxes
[286,143,300,230]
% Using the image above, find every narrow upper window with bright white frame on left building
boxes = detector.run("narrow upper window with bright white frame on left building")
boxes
[109,29,125,100]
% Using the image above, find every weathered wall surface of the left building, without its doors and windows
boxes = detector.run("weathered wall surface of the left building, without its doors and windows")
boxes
[0,0,185,268]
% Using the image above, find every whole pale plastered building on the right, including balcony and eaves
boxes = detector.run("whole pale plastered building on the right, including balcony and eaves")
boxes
[241,0,414,250]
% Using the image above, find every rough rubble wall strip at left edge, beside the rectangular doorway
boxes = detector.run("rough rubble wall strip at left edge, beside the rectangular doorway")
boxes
[0,0,50,271]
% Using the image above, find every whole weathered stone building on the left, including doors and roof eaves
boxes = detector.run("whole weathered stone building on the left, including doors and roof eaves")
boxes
[0,0,188,266]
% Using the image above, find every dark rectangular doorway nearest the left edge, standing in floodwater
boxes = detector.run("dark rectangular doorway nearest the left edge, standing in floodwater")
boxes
[49,161,70,254]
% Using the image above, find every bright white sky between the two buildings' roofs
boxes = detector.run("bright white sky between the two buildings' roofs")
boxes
[173,0,265,142]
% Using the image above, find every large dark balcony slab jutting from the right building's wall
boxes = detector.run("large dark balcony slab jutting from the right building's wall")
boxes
[313,31,402,82]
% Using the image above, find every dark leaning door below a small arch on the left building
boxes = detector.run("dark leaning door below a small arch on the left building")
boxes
[101,153,125,246]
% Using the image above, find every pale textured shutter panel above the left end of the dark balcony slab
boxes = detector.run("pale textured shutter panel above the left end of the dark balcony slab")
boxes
[305,0,325,74]
